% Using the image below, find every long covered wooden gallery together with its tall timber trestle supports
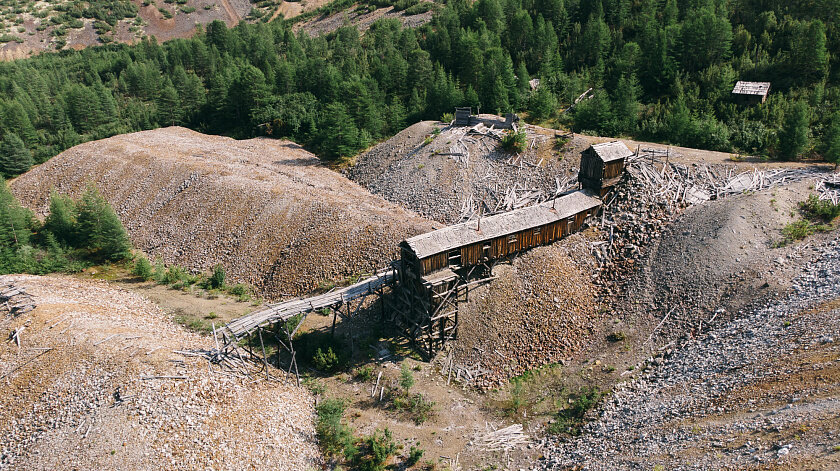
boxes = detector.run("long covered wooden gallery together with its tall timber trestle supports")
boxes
[392,191,601,357]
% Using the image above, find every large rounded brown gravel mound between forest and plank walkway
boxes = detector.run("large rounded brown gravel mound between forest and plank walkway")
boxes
[12,127,435,299]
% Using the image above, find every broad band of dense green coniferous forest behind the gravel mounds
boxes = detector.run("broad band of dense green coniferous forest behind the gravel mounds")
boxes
[0,0,840,177]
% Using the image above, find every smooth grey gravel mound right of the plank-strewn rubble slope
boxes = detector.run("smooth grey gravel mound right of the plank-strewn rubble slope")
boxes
[615,180,813,340]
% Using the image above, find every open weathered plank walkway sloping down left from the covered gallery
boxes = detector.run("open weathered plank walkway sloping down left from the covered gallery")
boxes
[226,267,397,339]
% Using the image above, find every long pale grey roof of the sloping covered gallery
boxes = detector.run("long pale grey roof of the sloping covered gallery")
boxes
[403,191,601,259]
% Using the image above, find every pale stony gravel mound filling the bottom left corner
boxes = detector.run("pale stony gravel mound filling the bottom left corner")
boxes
[0,275,320,471]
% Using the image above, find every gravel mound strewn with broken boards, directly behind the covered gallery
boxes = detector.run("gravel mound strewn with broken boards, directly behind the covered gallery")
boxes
[347,121,580,224]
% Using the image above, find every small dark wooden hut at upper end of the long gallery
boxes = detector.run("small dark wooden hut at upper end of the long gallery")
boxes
[578,141,634,196]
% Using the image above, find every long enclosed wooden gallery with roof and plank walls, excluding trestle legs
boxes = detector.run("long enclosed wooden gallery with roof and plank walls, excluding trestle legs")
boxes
[400,191,601,278]
